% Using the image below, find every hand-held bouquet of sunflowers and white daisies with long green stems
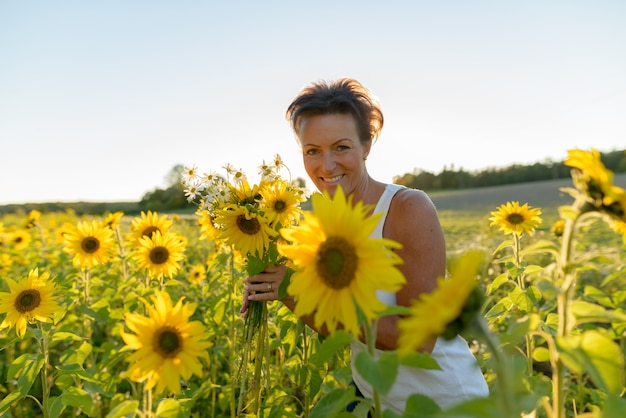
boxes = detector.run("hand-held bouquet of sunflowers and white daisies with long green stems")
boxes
[182,154,307,409]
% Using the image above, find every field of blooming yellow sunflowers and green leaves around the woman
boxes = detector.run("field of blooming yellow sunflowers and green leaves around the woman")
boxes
[0,149,626,418]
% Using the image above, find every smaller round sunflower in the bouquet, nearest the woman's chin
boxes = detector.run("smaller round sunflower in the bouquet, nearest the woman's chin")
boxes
[261,179,306,226]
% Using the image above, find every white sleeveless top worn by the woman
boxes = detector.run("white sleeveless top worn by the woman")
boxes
[350,184,489,413]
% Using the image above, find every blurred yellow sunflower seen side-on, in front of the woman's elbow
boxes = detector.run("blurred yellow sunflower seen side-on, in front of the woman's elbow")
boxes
[398,251,484,353]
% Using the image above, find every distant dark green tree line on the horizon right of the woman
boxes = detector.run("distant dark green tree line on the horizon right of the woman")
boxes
[393,150,626,191]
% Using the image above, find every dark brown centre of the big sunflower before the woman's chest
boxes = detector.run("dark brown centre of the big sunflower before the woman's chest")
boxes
[315,237,359,289]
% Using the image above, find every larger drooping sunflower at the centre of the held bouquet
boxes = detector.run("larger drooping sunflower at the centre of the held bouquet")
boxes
[215,205,278,257]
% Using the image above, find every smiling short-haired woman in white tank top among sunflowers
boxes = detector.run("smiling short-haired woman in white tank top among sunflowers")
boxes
[242,78,488,413]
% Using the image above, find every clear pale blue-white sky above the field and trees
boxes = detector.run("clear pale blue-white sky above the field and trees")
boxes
[0,0,626,204]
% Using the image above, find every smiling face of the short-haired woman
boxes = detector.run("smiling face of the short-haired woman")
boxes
[298,113,371,196]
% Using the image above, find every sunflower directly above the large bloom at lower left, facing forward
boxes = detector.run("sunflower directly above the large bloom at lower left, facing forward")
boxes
[133,231,186,277]
